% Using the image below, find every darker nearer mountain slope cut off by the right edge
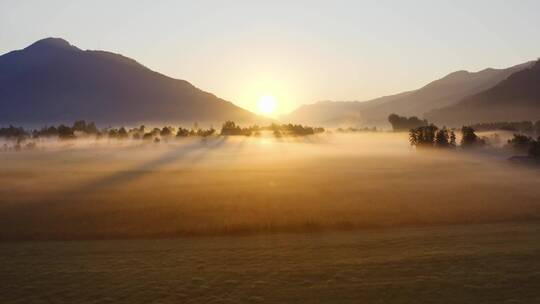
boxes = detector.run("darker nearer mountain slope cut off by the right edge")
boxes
[426,60,540,126]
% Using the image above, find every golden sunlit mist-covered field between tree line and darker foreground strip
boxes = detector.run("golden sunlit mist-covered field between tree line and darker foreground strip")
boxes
[0,133,540,240]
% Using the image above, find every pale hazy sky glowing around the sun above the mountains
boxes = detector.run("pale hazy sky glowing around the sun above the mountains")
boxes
[0,0,540,115]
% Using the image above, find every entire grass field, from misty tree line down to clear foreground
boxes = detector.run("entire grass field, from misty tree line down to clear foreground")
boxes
[0,133,540,303]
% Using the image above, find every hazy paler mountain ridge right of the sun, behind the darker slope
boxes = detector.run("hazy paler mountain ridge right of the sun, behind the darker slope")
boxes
[287,62,533,126]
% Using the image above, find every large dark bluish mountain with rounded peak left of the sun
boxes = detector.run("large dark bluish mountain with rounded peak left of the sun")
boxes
[0,38,257,125]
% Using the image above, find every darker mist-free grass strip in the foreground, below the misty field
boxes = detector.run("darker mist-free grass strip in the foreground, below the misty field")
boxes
[0,222,540,304]
